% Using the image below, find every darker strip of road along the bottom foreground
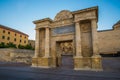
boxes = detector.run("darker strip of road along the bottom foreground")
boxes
[0,67,120,80]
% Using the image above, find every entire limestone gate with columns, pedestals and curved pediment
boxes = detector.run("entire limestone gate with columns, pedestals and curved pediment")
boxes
[32,7,102,70]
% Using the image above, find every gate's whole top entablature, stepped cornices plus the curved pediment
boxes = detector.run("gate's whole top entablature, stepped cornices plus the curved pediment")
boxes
[33,7,98,28]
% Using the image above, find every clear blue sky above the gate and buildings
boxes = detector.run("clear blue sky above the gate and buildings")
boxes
[0,0,120,40]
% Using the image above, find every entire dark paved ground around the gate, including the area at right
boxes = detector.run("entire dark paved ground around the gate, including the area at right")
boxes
[0,57,120,80]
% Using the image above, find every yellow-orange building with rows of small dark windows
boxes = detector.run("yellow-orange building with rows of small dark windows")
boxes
[0,25,29,46]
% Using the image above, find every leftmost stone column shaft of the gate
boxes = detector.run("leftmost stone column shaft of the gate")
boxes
[34,29,40,58]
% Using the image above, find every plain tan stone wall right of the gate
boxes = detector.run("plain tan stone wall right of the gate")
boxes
[98,29,120,54]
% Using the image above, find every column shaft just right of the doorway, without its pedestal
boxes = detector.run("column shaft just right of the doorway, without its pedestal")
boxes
[75,22,82,57]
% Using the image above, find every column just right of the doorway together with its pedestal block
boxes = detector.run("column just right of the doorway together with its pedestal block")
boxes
[74,22,83,70]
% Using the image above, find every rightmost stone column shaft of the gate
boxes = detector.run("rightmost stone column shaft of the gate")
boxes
[91,19,99,56]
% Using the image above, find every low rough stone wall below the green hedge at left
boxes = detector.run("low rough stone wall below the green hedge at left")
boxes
[0,48,34,64]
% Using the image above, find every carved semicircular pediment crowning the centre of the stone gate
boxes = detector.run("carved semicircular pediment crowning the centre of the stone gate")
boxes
[54,10,73,21]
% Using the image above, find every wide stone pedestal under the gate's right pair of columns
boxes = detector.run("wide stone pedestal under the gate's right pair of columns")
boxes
[74,56,102,71]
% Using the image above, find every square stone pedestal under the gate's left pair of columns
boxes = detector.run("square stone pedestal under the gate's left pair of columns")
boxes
[32,57,51,68]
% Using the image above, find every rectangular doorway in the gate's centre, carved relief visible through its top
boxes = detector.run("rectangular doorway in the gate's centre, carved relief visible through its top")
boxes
[56,40,74,69]
